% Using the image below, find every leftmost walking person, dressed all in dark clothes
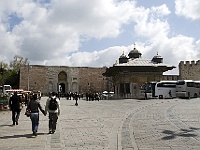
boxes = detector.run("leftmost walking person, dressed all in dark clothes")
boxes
[9,92,22,125]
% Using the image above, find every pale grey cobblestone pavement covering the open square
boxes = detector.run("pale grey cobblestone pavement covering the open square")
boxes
[0,97,200,150]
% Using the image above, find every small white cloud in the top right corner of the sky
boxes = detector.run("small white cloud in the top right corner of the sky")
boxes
[175,0,200,20]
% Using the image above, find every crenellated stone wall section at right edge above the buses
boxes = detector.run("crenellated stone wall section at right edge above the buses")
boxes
[179,60,200,80]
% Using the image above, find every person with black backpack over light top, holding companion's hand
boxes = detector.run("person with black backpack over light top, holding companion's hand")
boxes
[45,92,60,134]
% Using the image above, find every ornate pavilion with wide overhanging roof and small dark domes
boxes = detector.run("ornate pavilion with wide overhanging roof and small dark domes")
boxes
[104,48,175,98]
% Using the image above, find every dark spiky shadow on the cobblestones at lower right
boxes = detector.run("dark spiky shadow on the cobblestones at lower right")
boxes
[162,127,199,140]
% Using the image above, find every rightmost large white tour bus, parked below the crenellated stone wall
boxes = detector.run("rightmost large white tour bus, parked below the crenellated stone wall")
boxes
[176,80,199,98]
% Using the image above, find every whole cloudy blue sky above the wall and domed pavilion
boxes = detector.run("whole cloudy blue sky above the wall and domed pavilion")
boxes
[0,0,200,74]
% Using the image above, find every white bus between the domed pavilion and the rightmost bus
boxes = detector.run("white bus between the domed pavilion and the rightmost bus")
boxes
[155,81,177,99]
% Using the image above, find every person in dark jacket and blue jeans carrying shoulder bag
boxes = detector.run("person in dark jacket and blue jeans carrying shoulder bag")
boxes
[27,94,46,136]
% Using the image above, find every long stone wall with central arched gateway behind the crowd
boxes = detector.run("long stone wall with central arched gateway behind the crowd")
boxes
[20,65,109,93]
